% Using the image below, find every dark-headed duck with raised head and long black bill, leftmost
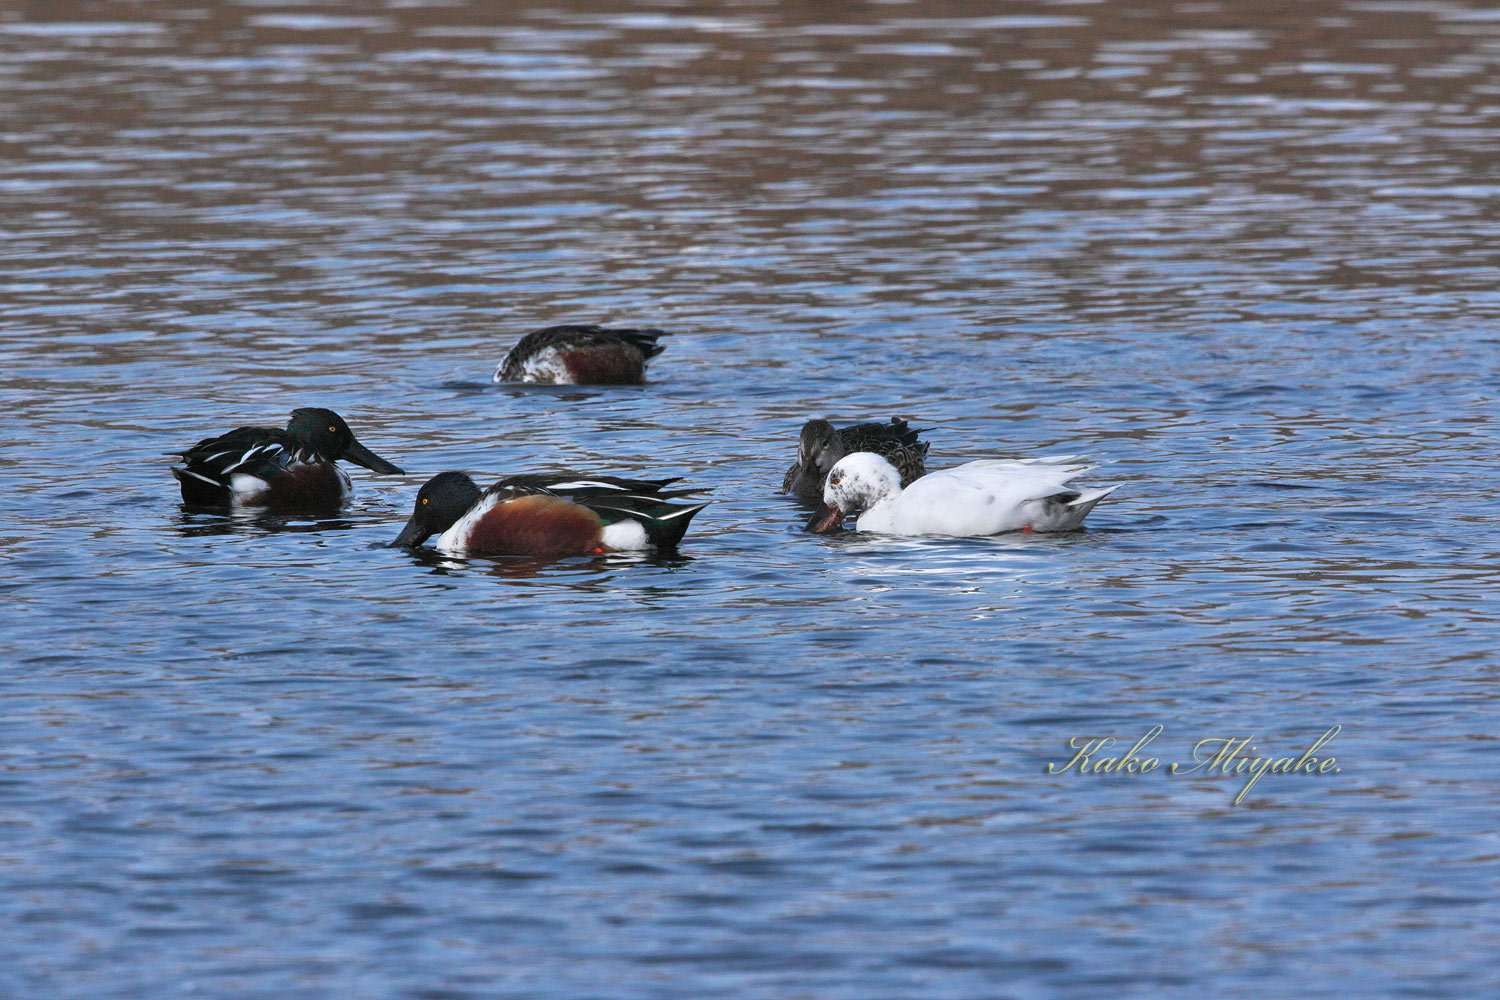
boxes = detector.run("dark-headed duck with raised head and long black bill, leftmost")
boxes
[173,406,402,508]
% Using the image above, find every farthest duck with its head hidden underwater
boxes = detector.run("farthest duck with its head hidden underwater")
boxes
[492,324,666,385]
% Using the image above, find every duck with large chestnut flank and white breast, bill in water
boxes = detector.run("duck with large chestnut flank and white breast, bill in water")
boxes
[390,472,708,556]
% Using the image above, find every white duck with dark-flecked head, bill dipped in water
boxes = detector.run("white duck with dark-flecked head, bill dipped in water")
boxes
[807,451,1119,537]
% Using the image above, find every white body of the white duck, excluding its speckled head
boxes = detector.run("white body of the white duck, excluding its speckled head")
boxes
[860,460,1101,537]
